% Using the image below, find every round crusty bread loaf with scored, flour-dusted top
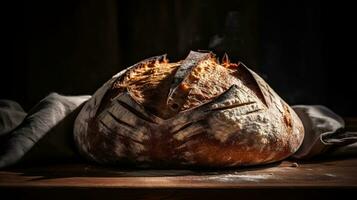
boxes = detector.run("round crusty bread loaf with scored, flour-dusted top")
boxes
[74,51,304,167]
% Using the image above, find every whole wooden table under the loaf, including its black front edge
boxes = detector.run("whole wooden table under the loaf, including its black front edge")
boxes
[0,158,357,200]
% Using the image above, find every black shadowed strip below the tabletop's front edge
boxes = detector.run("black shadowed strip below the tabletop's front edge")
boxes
[0,188,355,200]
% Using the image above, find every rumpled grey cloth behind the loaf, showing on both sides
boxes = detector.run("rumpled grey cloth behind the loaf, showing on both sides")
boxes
[0,93,357,168]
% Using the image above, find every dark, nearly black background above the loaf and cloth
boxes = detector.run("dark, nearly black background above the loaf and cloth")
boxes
[0,0,357,117]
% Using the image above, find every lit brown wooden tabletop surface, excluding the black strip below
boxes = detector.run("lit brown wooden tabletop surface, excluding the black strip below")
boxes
[0,158,357,189]
